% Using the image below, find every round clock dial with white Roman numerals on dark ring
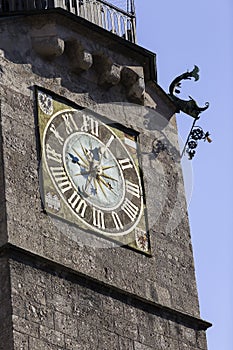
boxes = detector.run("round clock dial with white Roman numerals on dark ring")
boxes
[43,110,143,235]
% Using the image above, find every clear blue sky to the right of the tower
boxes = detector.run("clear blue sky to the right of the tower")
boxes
[136,0,233,350]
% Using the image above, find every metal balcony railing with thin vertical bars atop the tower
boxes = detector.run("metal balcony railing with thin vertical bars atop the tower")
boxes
[0,0,136,43]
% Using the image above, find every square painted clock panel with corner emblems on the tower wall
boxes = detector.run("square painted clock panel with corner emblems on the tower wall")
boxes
[37,89,150,254]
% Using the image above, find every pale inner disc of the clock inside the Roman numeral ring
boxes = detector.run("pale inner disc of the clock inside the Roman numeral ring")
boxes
[63,132,125,210]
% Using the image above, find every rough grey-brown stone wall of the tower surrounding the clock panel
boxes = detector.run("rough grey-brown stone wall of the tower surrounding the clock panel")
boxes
[0,10,208,350]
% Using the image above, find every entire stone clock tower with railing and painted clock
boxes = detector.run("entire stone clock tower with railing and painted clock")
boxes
[0,0,210,350]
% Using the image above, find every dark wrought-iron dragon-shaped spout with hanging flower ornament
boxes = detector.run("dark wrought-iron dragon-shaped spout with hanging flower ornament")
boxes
[168,66,212,159]
